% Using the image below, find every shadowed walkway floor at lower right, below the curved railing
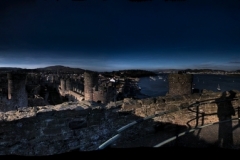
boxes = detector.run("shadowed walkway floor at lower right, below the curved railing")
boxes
[111,119,240,149]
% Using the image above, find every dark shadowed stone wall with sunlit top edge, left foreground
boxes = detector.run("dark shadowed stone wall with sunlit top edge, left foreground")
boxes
[0,102,148,156]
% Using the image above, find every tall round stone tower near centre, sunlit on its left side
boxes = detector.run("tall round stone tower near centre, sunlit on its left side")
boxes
[84,71,98,101]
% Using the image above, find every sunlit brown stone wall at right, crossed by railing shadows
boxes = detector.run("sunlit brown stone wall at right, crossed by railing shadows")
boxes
[121,90,240,127]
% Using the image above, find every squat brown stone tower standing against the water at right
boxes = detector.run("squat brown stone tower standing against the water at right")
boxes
[168,73,193,96]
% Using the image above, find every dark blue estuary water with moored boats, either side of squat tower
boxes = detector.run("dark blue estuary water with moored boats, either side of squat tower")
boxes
[138,74,240,97]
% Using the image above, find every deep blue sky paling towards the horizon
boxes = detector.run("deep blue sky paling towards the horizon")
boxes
[0,0,240,71]
